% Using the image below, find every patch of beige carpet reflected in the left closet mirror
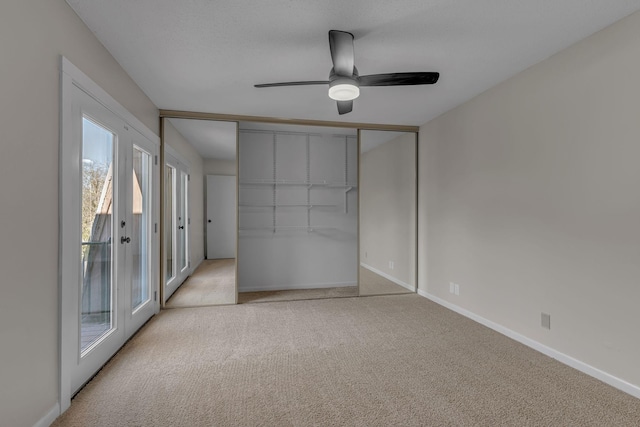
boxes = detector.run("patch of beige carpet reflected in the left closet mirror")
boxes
[166,259,236,308]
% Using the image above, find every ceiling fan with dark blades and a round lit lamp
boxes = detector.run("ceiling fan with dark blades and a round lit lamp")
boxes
[255,30,440,114]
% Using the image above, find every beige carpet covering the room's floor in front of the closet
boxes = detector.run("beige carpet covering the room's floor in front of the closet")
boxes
[53,294,640,427]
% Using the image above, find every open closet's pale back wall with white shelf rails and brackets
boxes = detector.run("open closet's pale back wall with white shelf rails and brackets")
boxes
[237,129,358,292]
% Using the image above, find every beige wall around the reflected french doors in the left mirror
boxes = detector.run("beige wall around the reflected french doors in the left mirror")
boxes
[164,120,204,269]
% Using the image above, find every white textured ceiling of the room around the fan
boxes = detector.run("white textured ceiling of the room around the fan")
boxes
[67,0,640,125]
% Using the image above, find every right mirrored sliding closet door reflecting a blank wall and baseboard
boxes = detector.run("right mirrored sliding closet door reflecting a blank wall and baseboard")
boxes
[359,130,417,295]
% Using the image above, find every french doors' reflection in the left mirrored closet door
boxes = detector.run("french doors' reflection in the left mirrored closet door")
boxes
[164,147,191,301]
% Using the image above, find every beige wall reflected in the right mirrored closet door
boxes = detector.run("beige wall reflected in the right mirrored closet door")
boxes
[360,131,416,287]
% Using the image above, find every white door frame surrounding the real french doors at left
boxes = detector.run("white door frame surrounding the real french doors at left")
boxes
[58,56,160,413]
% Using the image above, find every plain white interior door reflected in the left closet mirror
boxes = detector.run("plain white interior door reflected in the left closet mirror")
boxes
[207,175,236,259]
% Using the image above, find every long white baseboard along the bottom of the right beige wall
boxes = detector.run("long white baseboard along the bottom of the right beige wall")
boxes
[418,289,640,399]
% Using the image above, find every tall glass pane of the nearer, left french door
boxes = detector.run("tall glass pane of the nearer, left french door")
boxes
[80,117,115,354]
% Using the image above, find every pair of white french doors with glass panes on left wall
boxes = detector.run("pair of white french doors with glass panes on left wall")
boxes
[60,60,159,404]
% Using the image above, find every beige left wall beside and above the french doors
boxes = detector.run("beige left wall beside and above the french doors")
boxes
[0,0,158,426]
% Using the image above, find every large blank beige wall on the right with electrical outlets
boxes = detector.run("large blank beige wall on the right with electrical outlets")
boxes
[419,13,640,386]
